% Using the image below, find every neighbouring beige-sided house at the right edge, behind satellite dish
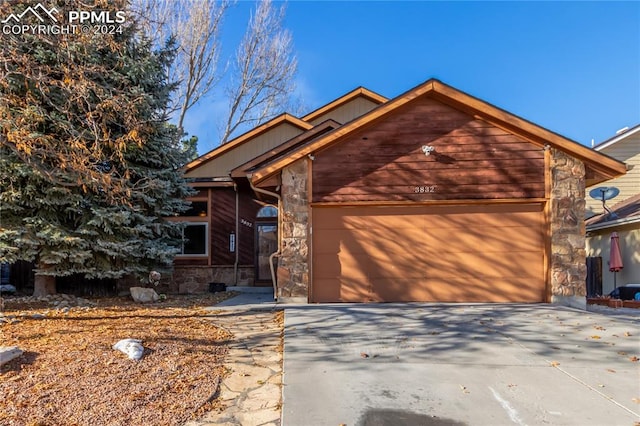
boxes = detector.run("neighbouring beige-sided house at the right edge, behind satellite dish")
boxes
[586,124,640,294]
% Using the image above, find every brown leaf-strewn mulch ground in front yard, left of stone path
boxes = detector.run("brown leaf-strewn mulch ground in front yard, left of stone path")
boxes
[0,293,238,425]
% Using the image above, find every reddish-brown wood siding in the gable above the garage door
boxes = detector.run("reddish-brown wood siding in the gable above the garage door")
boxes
[312,98,545,202]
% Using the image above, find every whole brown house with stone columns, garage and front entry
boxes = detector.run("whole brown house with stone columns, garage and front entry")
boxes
[172,79,626,307]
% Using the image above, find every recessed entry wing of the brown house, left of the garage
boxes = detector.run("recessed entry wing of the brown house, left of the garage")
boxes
[169,88,387,293]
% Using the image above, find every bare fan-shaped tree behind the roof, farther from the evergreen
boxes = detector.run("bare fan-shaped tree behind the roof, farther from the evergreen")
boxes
[221,0,297,143]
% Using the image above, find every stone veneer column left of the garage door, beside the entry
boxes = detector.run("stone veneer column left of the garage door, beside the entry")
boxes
[278,158,309,303]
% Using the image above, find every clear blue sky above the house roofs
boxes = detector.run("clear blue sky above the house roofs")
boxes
[185,0,640,154]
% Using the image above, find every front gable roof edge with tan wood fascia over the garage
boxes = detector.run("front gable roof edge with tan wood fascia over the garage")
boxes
[251,79,626,185]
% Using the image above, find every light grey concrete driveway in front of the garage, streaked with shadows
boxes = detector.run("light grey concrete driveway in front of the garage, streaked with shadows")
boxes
[282,304,640,426]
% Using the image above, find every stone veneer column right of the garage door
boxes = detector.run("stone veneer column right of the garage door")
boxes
[550,149,587,309]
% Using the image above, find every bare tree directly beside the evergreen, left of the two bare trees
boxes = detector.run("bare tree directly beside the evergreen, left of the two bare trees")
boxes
[131,0,229,132]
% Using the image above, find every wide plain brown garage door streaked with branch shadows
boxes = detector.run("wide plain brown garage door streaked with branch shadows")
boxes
[311,204,545,302]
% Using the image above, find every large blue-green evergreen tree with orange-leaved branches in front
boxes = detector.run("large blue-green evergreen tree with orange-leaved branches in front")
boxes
[0,0,191,295]
